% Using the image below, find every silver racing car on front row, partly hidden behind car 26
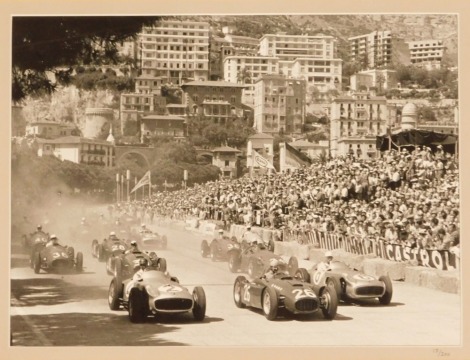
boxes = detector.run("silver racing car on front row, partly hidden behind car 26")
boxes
[295,261,393,305]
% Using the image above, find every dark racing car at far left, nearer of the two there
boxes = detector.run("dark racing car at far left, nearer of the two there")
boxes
[32,245,83,274]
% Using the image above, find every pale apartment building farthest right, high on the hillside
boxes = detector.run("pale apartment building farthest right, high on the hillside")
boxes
[408,40,445,70]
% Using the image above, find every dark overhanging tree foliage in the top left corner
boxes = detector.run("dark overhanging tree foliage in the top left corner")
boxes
[12,16,159,102]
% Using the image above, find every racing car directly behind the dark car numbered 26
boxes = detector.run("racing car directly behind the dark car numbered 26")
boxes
[228,244,299,278]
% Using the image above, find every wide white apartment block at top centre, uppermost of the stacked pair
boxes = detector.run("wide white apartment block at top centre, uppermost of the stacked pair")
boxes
[259,33,336,60]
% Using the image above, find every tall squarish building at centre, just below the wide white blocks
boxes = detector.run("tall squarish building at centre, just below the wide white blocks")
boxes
[254,75,306,134]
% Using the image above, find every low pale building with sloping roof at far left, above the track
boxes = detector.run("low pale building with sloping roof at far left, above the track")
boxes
[37,136,115,167]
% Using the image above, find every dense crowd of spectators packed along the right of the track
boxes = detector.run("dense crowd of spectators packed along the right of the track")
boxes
[113,146,460,252]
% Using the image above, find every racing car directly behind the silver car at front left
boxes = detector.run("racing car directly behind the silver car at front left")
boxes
[106,251,167,279]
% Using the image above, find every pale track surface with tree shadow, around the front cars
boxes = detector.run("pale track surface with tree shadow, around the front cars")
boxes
[10,222,462,346]
